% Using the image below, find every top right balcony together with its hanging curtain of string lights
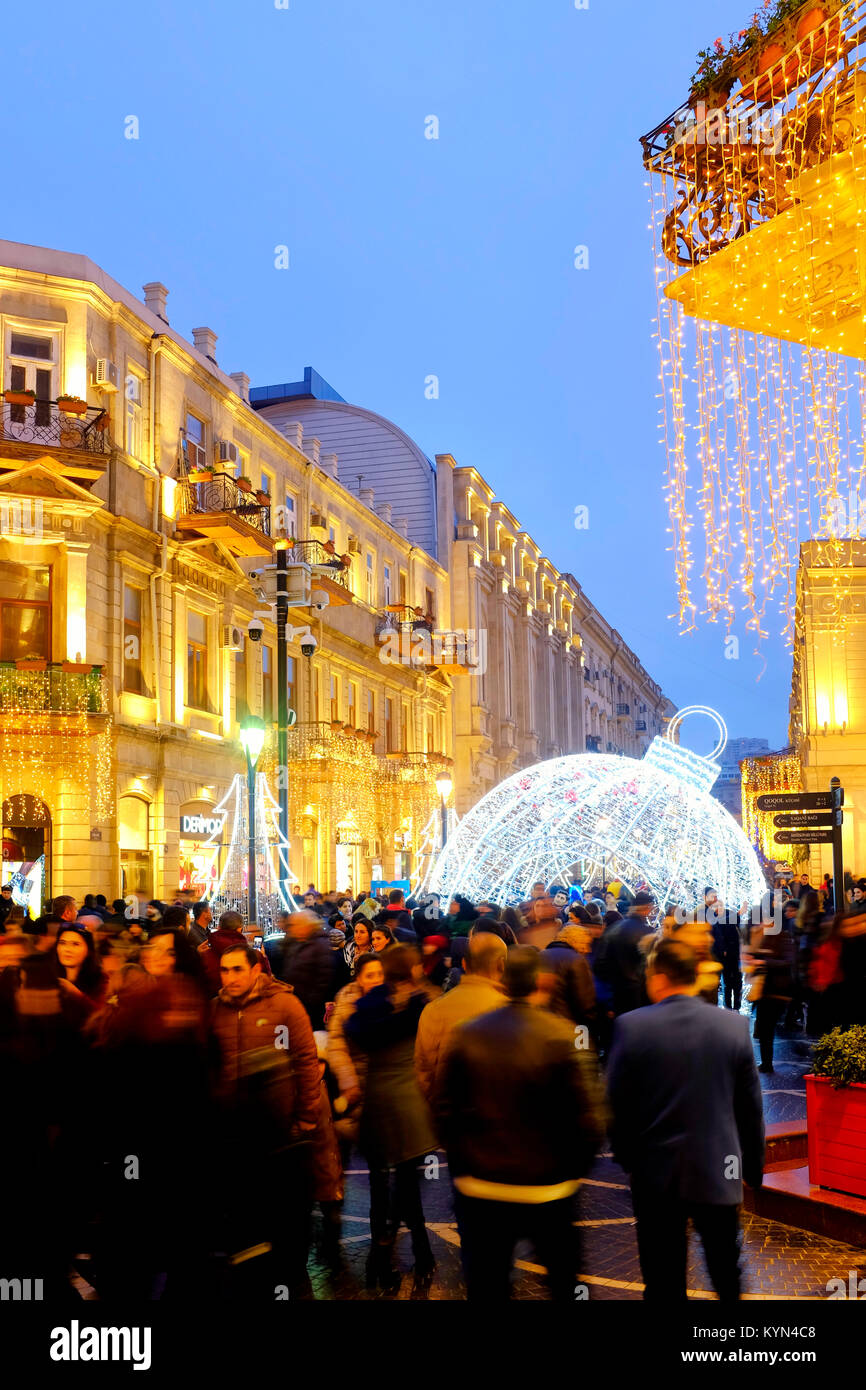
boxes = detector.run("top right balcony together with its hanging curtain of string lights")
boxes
[642,0,866,651]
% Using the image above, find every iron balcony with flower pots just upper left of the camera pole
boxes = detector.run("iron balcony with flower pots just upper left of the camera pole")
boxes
[175,468,274,556]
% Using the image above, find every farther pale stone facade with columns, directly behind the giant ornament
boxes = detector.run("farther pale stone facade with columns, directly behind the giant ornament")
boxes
[436,455,674,815]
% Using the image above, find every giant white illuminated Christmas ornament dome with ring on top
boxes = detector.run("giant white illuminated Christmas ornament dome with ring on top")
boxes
[427,705,766,909]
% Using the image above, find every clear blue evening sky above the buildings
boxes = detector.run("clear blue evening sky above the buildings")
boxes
[0,0,791,751]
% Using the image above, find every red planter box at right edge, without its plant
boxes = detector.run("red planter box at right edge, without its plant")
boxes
[806,1076,866,1197]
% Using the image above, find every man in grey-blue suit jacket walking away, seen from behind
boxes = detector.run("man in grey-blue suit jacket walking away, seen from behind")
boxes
[607,938,765,1302]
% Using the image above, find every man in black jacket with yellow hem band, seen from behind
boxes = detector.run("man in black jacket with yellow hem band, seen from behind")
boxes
[436,947,605,1302]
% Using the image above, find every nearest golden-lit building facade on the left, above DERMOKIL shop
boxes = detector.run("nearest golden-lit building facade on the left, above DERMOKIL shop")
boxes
[0,242,452,899]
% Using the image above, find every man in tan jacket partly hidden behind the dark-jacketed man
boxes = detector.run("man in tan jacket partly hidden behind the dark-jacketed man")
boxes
[416,931,507,1105]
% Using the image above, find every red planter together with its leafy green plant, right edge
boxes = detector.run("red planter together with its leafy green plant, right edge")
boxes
[806,1024,866,1197]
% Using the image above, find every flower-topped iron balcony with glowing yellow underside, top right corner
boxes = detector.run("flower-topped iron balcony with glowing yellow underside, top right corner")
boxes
[641,0,866,357]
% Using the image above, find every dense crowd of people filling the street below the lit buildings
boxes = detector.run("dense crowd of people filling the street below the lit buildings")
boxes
[0,876,866,1301]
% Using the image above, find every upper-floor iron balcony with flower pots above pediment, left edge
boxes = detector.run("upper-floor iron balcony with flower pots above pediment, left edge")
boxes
[0,391,111,480]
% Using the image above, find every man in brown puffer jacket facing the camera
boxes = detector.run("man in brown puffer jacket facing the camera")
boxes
[210,942,320,1298]
